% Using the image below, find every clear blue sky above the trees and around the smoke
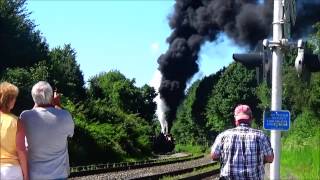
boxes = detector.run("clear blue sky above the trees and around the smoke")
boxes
[27,0,240,86]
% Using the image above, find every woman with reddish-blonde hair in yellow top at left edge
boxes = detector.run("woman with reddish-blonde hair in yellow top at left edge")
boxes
[0,82,29,180]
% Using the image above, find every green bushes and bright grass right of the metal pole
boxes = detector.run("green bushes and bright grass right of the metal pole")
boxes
[281,23,320,179]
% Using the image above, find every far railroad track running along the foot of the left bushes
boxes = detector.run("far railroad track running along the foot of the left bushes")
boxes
[69,155,204,177]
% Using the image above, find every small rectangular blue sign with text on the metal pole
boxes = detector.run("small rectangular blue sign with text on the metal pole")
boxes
[263,111,290,131]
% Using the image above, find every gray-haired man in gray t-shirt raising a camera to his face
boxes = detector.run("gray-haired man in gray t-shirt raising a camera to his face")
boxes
[20,81,74,180]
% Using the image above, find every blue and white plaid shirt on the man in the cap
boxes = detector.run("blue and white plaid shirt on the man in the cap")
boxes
[211,124,273,180]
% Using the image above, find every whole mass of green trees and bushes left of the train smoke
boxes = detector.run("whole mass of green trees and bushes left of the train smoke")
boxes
[0,0,156,165]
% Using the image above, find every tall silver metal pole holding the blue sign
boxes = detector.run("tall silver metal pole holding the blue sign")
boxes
[270,0,283,180]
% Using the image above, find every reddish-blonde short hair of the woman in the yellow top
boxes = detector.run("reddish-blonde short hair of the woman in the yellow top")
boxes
[0,82,19,110]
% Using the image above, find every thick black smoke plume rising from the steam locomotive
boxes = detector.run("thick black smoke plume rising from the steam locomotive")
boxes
[158,0,320,132]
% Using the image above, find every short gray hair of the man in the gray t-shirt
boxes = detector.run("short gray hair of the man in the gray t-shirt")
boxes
[31,81,53,105]
